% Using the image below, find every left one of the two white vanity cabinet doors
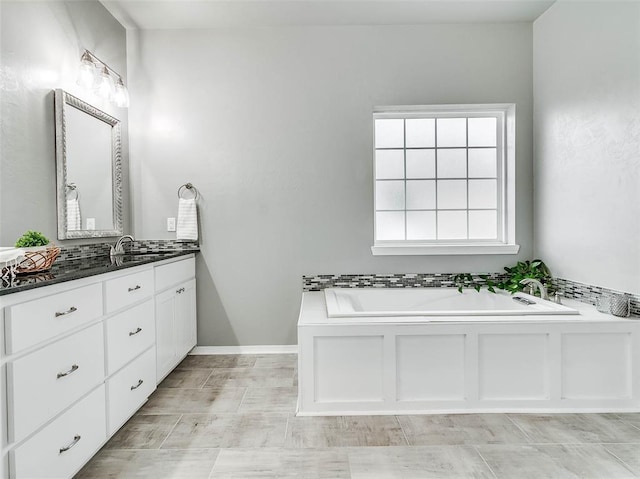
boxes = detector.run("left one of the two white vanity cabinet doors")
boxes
[156,288,178,382]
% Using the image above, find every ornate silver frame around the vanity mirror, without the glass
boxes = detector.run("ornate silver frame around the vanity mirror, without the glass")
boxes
[55,89,123,239]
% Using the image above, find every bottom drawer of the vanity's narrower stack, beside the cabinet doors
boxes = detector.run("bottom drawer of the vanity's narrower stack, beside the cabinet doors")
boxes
[107,348,156,435]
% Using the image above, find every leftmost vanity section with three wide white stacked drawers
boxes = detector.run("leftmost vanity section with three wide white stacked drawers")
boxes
[0,276,107,479]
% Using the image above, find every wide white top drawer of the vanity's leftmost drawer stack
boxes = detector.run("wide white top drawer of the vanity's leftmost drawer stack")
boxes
[5,283,102,354]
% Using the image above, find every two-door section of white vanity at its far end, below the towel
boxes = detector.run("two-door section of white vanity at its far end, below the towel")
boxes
[155,258,196,383]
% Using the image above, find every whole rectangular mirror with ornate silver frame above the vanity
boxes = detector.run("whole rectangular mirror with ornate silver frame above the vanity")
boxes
[55,90,123,239]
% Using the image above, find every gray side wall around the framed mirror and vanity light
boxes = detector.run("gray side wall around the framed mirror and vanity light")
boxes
[0,0,131,246]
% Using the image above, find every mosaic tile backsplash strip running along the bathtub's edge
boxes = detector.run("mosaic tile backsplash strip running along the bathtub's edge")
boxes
[302,273,640,316]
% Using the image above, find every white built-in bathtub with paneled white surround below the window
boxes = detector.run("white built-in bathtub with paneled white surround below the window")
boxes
[298,288,640,415]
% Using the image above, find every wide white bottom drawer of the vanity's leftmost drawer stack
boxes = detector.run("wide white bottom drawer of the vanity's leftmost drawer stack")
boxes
[12,385,107,479]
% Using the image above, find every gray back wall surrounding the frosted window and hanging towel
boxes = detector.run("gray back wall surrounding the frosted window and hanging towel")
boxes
[128,24,533,345]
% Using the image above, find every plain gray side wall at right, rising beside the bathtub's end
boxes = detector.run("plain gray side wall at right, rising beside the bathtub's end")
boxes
[534,2,640,293]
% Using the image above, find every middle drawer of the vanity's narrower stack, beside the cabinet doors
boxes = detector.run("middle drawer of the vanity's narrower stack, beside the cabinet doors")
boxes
[106,299,156,374]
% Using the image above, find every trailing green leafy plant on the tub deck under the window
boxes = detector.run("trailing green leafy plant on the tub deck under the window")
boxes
[453,259,553,294]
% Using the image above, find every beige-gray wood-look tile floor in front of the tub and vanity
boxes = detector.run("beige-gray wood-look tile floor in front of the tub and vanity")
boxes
[76,354,640,479]
